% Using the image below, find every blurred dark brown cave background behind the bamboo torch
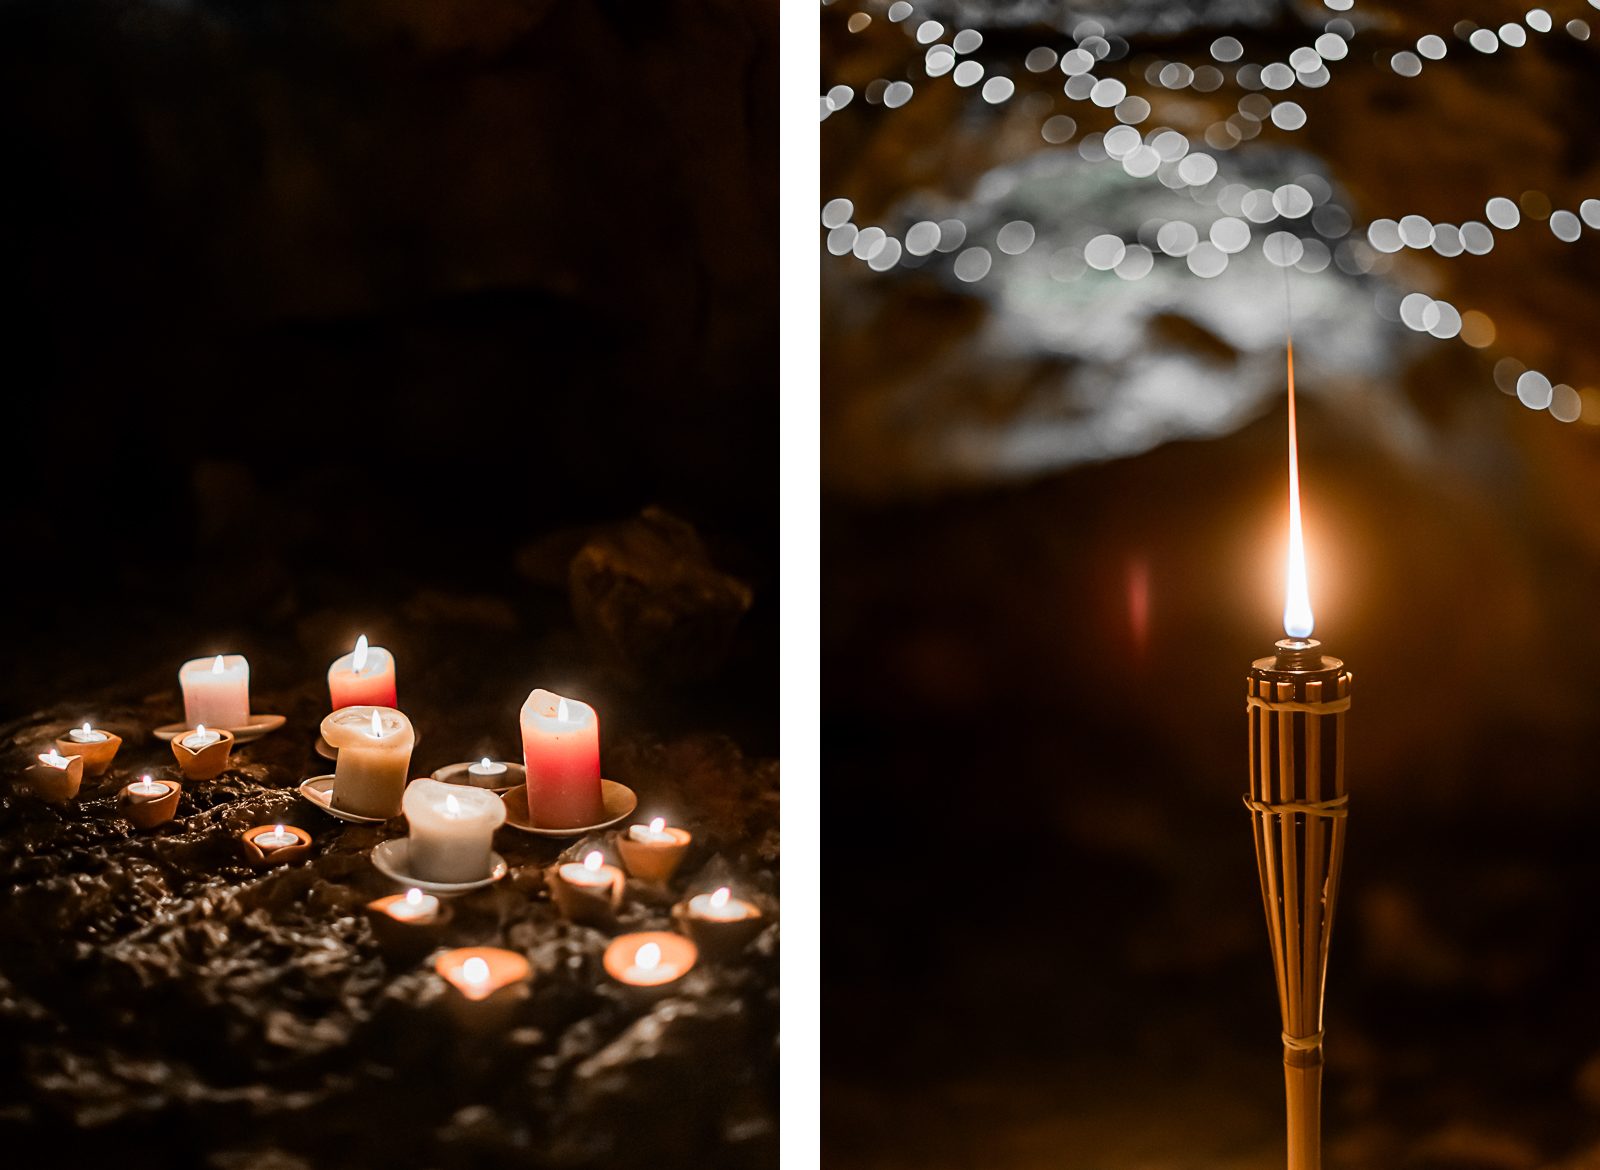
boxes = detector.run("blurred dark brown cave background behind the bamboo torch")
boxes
[819,2,1600,1170]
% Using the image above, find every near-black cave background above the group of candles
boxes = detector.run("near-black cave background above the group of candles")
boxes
[0,0,778,751]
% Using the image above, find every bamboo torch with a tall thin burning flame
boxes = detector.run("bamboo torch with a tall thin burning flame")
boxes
[1245,343,1350,1170]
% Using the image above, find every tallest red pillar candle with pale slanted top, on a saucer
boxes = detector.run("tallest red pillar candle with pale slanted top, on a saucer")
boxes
[522,690,603,829]
